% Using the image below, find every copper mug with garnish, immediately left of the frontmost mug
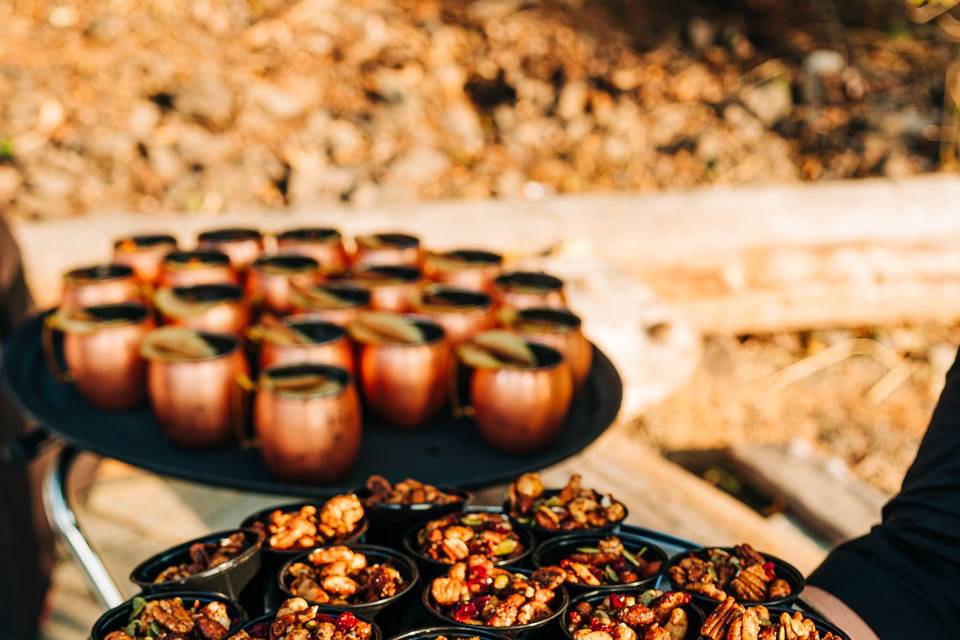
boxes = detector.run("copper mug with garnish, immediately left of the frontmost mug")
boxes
[141,327,247,449]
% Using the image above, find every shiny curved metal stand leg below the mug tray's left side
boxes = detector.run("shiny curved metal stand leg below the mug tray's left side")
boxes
[43,447,124,609]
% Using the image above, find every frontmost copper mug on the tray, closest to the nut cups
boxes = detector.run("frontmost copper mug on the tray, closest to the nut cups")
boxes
[253,363,362,484]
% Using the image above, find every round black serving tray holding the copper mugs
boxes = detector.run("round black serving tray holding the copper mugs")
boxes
[3,315,623,497]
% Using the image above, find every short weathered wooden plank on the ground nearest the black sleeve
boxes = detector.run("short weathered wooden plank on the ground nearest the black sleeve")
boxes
[730,445,887,544]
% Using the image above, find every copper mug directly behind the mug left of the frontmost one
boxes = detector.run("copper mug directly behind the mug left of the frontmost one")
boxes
[153,282,250,334]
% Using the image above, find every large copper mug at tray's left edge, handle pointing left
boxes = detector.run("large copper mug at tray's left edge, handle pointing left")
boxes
[43,303,153,411]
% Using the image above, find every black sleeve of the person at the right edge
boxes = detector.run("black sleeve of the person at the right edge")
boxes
[808,358,960,640]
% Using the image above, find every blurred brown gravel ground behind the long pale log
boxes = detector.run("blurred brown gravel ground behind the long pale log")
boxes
[0,0,954,216]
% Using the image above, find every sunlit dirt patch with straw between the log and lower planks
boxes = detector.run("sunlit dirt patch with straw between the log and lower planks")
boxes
[634,326,960,494]
